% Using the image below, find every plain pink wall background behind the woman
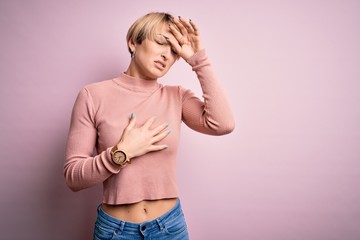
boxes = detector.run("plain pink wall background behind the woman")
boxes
[0,0,360,240]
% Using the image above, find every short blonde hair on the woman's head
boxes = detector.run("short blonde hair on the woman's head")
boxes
[126,12,176,54]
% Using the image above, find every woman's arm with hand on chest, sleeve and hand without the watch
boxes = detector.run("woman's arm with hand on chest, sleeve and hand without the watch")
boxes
[64,88,170,191]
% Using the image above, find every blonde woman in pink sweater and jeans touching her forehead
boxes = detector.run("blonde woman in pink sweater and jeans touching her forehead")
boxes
[64,12,234,240]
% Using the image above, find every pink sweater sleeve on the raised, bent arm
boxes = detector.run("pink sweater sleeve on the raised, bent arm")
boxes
[182,50,235,135]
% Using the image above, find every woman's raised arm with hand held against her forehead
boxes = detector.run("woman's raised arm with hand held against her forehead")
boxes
[167,17,235,135]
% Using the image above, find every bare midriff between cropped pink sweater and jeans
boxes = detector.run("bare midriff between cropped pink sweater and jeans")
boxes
[102,198,177,223]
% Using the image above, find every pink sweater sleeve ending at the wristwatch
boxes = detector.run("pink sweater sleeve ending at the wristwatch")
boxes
[64,88,120,191]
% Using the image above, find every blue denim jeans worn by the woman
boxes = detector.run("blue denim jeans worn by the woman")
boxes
[94,200,189,240]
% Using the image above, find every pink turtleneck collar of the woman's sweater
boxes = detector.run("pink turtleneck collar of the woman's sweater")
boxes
[113,73,161,93]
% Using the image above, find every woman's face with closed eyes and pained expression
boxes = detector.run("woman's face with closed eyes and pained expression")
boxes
[127,24,178,80]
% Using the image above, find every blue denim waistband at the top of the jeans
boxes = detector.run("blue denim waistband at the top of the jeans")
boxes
[98,199,182,233]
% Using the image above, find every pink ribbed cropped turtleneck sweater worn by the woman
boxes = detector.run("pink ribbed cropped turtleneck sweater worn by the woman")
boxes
[64,50,234,204]
